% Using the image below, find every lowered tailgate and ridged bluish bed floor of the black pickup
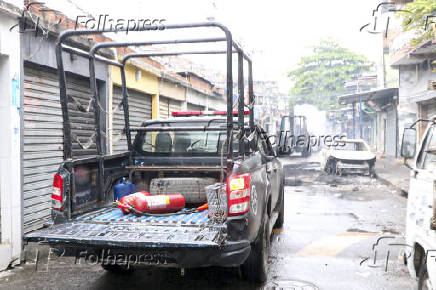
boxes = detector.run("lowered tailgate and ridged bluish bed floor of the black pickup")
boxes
[24,209,222,248]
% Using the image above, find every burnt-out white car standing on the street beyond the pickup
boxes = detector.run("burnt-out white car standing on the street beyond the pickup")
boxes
[321,139,376,177]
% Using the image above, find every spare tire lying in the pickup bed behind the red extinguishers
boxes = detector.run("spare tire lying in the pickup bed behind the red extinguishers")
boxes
[150,177,217,203]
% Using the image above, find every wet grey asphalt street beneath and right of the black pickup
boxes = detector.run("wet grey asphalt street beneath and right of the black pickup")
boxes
[0,157,414,290]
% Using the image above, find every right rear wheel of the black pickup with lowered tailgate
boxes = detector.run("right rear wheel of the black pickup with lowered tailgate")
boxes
[241,213,270,283]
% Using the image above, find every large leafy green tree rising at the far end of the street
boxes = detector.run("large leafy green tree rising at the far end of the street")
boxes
[288,39,372,110]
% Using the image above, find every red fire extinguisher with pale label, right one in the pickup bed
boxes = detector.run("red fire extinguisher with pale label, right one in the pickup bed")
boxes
[132,193,185,214]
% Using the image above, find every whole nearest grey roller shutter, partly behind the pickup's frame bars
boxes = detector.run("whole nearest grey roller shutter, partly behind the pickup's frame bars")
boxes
[22,67,96,233]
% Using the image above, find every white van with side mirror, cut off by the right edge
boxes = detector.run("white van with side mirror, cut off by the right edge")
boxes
[401,116,436,290]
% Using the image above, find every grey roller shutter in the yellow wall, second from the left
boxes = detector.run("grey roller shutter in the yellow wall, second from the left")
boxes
[112,87,151,153]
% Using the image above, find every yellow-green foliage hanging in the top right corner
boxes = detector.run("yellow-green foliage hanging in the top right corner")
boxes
[399,0,436,47]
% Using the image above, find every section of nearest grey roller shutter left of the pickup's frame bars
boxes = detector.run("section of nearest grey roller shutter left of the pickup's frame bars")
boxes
[22,68,63,233]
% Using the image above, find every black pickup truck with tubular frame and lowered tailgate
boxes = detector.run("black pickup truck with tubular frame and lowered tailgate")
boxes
[24,23,284,282]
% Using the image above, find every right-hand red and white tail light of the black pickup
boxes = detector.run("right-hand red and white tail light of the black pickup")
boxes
[227,173,251,216]
